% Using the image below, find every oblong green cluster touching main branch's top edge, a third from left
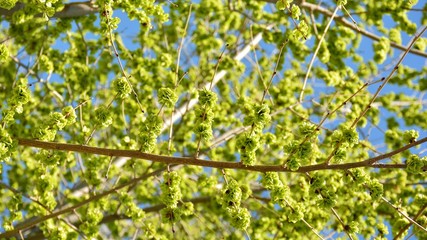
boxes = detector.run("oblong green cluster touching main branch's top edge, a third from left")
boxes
[139,114,163,152]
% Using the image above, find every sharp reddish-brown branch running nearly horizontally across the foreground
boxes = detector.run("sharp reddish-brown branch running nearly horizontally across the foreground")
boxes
[18,137,427,173]
